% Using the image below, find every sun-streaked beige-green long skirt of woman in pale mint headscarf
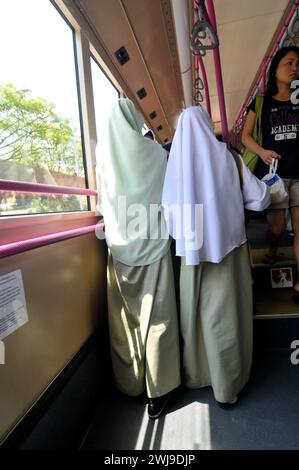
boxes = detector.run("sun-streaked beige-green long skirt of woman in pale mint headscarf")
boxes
[108,251,180,398]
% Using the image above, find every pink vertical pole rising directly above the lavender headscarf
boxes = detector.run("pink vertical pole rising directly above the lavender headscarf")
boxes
[207,0,228,142]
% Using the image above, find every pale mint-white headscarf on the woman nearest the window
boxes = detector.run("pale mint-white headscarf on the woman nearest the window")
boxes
[97,98,170,266]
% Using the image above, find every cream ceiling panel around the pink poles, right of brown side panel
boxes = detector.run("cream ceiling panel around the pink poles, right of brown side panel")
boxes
[189,0,298,140]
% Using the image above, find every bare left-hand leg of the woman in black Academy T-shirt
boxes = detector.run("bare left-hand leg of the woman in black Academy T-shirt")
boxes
[267,208,288,262]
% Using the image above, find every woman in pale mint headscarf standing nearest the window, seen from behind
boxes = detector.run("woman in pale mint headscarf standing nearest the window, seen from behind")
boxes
[97,99,180,418]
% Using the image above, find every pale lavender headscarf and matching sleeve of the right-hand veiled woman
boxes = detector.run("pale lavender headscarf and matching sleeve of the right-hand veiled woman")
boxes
[162,106,270,265]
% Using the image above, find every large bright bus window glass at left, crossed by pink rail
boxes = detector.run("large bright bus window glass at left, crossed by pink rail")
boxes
[0,0,87,215]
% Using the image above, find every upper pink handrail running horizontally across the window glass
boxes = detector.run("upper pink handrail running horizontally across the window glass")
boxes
[0,179,98,196]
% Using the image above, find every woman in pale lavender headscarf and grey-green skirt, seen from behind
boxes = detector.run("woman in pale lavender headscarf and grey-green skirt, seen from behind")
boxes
[162,107,270,403]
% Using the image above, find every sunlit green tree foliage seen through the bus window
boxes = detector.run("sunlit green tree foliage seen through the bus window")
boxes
[0,83,84,176]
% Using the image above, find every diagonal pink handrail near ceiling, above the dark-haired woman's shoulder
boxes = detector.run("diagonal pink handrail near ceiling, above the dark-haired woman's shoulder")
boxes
[234,0,299,132]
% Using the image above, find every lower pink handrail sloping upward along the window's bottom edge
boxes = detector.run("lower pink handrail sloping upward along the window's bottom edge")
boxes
[0,224,104,258]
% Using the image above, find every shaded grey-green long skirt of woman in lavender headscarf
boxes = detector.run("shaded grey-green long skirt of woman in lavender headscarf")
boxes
[180,243,252,403]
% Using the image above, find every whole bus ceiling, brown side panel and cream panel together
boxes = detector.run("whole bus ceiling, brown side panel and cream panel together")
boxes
[65,0,298,143]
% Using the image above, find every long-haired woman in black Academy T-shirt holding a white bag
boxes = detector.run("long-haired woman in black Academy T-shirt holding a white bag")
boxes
[242,46,299,294]
